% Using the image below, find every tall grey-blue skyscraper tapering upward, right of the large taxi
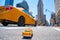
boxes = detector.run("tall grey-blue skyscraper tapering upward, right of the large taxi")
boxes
[37,0,44,25]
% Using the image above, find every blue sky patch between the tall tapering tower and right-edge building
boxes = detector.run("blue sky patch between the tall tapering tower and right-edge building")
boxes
[43,0,55,22]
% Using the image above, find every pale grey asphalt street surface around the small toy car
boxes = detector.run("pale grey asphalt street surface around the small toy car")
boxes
[0,26,60,40]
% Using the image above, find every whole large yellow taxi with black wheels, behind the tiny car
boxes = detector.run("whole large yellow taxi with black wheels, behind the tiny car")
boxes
[0,5,36,26]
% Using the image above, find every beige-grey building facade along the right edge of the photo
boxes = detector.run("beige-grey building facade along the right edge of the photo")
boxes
[54,0,60,25]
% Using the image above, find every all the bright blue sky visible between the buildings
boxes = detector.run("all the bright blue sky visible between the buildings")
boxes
[0,0,55,22]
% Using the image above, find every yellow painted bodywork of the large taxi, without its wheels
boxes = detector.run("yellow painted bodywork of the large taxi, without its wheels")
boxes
[0,6,36,25]
